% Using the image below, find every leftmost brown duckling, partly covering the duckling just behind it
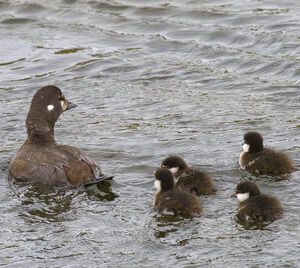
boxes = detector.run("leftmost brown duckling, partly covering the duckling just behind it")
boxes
[154,168,202,216]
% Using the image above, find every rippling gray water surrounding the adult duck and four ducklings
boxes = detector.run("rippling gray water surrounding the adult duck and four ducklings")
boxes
[0,0,300,267]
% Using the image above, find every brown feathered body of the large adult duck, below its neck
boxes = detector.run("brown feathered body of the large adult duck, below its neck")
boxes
[9,143,102,186]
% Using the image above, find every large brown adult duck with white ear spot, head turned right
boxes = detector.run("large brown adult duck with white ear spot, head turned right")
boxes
[9,86,111,187]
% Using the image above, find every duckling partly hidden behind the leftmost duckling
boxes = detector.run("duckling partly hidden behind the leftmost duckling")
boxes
[161,155,216,195]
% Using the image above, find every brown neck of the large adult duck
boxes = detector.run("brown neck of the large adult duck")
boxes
[25,119,56,145]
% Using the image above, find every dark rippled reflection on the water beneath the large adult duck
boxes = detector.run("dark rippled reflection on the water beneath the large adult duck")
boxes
[11,181,118,222]
